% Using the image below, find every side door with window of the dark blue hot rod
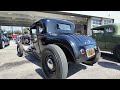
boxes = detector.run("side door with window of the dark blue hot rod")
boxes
[30,22,45,56]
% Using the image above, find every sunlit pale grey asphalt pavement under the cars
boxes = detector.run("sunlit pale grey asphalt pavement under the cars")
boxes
[0,41,120,79]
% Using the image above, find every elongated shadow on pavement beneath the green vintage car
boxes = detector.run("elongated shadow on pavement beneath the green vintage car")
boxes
[98,62,120,70]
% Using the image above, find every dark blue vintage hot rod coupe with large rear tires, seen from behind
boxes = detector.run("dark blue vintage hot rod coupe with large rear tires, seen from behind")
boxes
[17,18,101,79]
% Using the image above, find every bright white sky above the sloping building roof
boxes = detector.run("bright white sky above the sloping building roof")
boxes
[62,11,120,23]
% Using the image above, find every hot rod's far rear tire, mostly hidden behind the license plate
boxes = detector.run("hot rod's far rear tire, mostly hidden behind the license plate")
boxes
[83,48,101,65]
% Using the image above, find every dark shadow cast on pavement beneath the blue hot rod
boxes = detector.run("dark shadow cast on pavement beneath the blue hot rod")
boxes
[25,53,87,79]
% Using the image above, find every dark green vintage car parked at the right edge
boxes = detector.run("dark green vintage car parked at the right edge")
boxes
[91,24,120,61]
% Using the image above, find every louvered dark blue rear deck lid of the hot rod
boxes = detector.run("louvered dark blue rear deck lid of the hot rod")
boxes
[59,34,96,46]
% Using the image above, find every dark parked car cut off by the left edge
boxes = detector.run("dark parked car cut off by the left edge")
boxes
[0,30,10,49]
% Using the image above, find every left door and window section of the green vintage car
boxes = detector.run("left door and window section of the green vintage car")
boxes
[92,29,106,51]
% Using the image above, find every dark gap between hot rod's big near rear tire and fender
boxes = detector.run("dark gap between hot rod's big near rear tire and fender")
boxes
[54,43,75,63]
